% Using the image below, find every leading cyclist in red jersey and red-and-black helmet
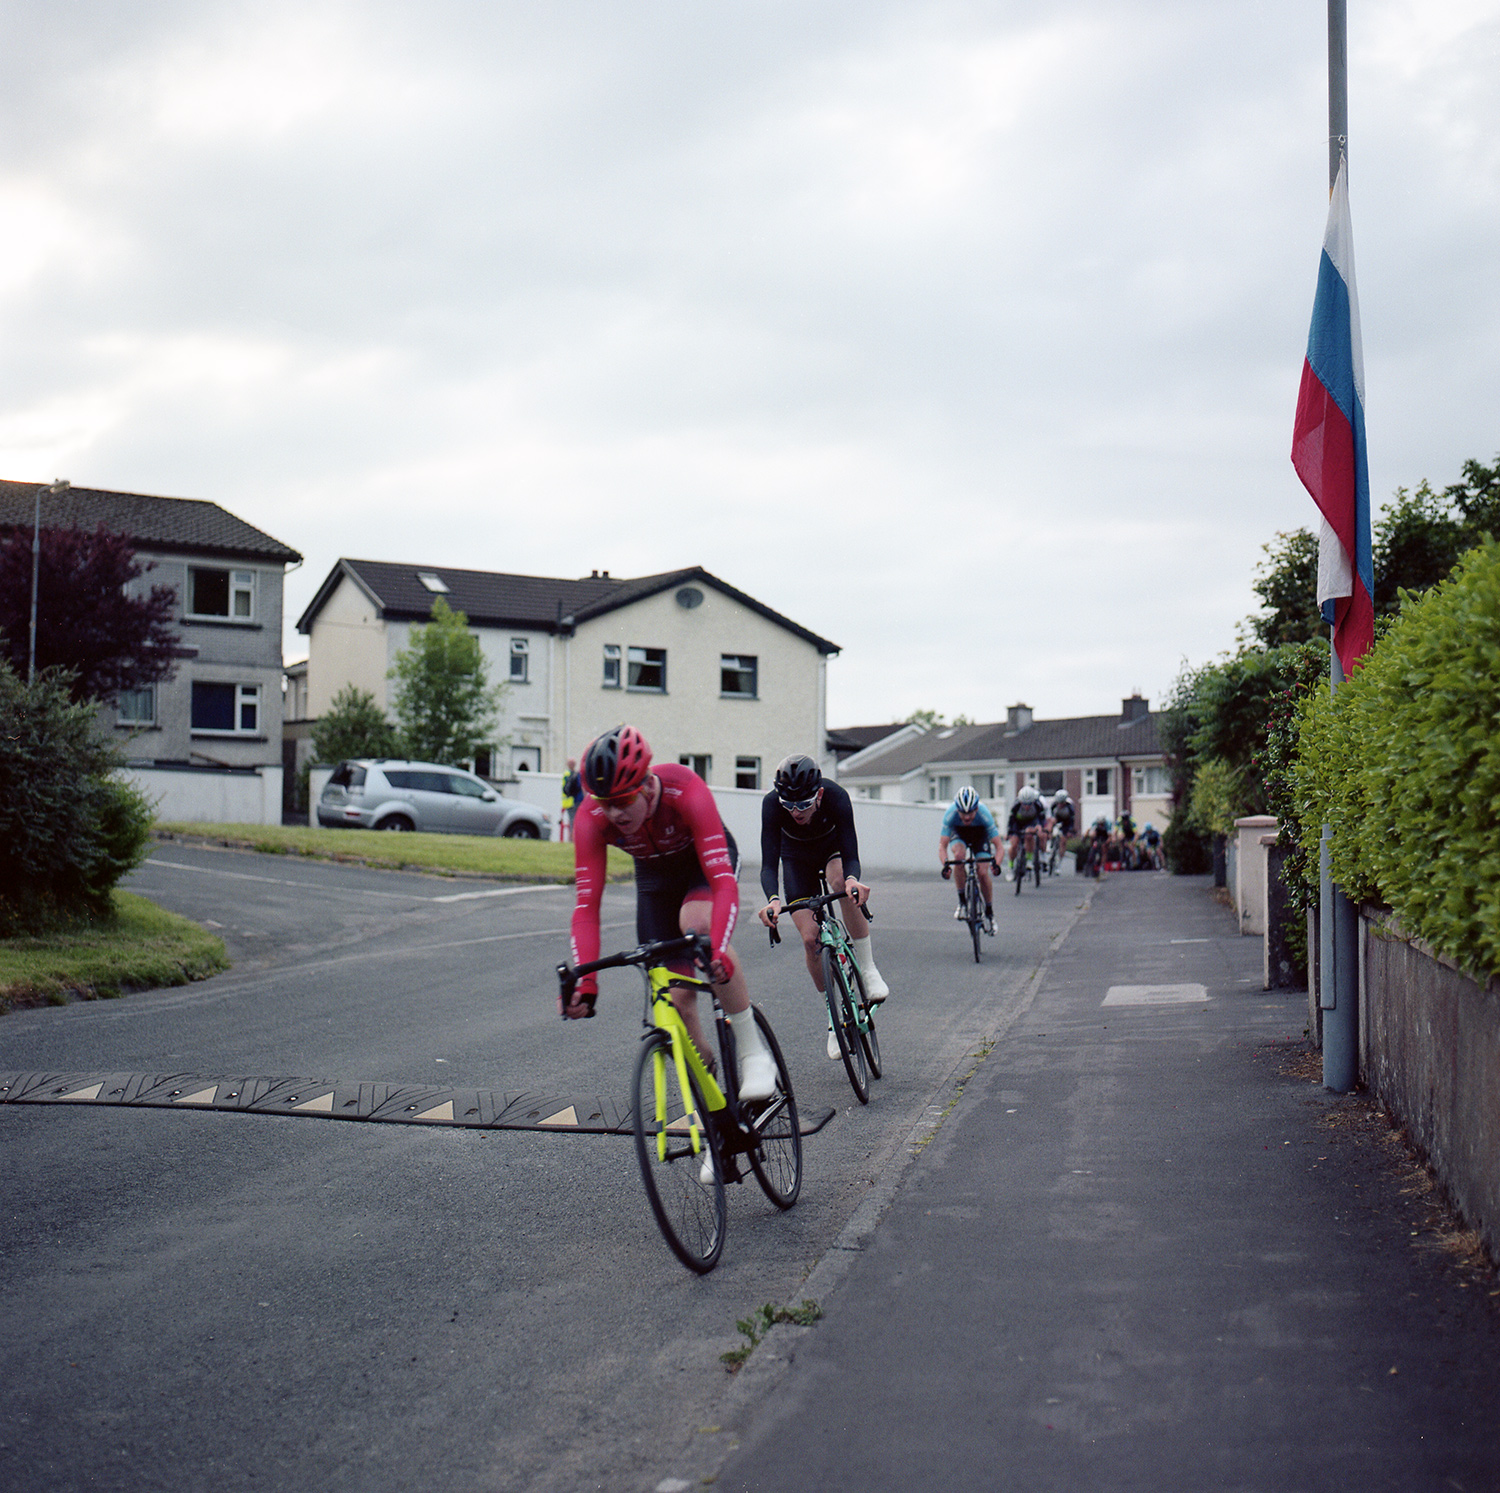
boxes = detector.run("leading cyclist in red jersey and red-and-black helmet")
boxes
[563,726,776,1098]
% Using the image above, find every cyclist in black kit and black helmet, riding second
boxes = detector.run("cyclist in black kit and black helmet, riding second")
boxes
[761,753,891,1058]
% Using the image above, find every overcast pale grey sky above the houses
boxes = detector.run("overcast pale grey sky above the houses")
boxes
[0,0,1500,725]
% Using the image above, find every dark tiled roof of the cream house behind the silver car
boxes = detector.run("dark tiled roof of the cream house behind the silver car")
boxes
[297,560,839,653]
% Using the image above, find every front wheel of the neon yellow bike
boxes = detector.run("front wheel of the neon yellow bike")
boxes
[633,1031,729,1274]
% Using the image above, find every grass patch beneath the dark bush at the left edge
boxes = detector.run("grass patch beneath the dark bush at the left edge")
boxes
[0,891,230,1013]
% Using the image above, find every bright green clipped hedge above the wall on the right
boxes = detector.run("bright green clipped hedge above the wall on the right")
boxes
[1293,540,1500,977]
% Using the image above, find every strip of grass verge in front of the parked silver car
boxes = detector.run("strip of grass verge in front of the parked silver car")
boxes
[152,824,633,882]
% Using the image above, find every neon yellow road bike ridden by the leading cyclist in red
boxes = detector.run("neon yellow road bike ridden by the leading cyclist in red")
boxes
[558,933,803,1274]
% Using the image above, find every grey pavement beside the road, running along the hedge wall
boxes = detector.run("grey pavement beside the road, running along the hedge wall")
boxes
[716,873,1500,1493]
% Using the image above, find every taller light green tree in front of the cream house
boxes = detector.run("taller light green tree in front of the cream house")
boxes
[389,596,506,764]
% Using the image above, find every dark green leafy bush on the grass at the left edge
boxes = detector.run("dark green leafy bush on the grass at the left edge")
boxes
[0,662,153,936]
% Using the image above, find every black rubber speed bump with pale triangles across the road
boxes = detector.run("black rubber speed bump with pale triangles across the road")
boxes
[0,1073,834,1136]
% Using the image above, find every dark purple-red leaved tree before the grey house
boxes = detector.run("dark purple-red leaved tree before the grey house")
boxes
[0,525,180,704]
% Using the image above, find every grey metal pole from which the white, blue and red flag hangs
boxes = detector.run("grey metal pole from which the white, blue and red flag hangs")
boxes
[1317,0,1359,1094]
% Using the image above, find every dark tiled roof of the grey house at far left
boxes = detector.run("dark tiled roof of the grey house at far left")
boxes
[0,480,302,564]
